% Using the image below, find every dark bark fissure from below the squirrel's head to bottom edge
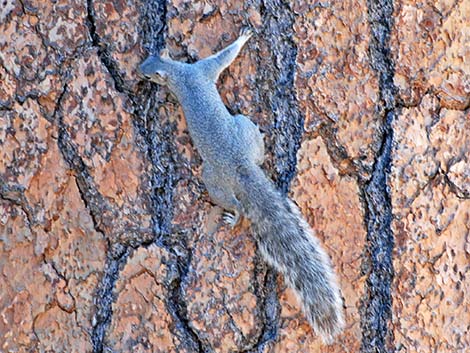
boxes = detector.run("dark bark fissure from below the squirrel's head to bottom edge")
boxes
[136,90,206,352]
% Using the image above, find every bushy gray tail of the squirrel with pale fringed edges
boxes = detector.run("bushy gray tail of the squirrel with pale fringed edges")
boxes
[237,166,344,343]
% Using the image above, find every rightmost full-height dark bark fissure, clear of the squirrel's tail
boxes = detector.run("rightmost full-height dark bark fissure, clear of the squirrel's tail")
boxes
[360,0,397,352]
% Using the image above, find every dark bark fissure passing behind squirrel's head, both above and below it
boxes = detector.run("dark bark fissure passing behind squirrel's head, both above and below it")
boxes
[134,0,208,352]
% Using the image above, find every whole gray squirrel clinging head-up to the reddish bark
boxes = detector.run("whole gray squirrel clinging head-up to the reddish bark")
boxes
[139,29,344,343]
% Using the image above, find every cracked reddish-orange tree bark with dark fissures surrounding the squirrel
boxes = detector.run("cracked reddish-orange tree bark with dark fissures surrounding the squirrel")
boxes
[0,0,470,353]
